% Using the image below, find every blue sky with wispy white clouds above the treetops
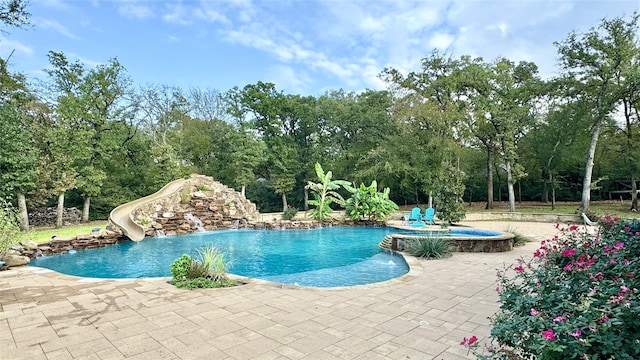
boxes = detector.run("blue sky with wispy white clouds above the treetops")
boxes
[0,0,640,96]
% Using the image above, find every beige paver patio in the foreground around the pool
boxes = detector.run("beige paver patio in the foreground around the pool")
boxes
[0,222,568,360]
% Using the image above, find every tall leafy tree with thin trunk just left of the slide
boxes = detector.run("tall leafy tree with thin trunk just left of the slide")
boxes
[47,51,133,221]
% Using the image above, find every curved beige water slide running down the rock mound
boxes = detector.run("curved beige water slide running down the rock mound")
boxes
[109,179,188,241]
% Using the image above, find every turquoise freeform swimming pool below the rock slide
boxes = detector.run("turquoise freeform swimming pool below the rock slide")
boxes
[30,227,409,287]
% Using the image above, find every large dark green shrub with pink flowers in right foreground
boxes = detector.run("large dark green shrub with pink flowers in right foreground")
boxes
[463,217,640,359]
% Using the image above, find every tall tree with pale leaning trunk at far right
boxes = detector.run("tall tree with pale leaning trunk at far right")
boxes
[556,13,639,212]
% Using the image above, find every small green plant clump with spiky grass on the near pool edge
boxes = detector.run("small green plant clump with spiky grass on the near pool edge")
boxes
[169,245,237,290]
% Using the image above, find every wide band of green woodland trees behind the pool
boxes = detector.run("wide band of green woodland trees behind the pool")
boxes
[0,8,640,222]
